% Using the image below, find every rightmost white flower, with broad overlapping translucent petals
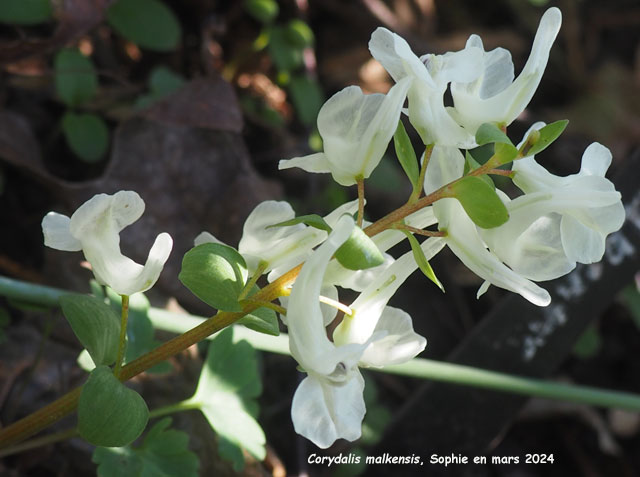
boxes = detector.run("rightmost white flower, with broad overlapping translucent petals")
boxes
[482,131,625,280]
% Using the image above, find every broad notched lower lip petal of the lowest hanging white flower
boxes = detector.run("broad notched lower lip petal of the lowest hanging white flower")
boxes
[291,371,366,449]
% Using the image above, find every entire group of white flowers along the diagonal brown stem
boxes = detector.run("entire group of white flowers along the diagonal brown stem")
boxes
[43,8,624,454]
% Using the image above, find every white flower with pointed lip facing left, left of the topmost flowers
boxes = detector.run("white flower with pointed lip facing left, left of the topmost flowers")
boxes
[278,79,411,186]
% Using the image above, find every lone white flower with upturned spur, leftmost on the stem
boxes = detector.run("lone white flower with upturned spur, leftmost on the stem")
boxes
[42,191,173,295]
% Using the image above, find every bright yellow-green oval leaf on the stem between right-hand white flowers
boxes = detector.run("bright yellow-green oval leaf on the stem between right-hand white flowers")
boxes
[447,176,509,229]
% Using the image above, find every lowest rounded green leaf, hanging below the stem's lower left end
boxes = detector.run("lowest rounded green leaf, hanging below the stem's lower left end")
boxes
[78,366,149,447]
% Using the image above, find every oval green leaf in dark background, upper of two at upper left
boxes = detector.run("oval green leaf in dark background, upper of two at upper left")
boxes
[53,49,98,107]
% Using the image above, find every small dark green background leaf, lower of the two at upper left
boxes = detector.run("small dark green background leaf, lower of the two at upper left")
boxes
[62,111,109,162]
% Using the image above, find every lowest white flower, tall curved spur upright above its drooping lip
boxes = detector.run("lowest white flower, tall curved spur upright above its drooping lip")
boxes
[287,216,366,448]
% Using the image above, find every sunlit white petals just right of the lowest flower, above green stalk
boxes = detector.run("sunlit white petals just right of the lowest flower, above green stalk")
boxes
[360,306,427,368]
